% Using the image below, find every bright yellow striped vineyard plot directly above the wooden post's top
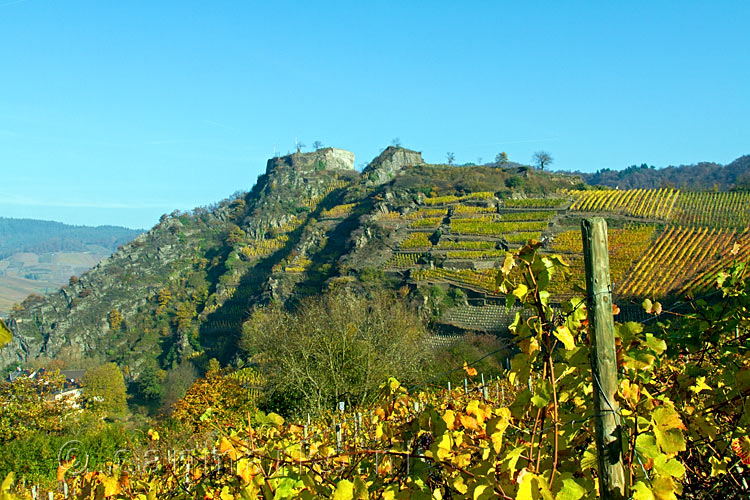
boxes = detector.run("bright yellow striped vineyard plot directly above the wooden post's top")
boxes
[570,188,680,219]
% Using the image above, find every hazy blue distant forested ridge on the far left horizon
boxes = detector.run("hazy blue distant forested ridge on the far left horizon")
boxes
[0,217,143,259]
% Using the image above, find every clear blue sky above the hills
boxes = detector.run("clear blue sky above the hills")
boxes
[0,0,750,228]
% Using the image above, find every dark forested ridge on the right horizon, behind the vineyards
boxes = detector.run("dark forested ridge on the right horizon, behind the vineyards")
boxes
[578,155,750,191]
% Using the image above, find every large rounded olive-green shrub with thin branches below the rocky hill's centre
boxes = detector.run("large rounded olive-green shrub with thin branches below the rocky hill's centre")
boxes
[241,290,426,414]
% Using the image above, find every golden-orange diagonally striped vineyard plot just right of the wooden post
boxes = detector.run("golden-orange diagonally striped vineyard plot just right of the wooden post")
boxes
[619,226,748,299]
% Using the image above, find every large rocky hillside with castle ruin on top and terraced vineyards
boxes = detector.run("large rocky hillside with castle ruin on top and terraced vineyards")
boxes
[0,147,750,379]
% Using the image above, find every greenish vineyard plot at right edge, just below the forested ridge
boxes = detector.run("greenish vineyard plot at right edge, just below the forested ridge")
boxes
[672,191,750,228]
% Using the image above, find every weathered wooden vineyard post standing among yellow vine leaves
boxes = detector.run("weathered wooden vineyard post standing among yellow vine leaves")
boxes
[581,217,625,499]
